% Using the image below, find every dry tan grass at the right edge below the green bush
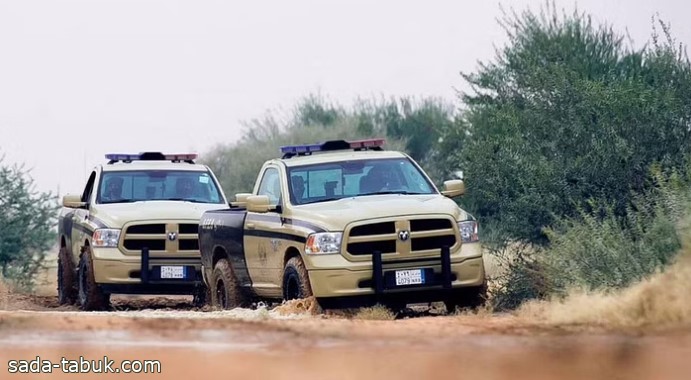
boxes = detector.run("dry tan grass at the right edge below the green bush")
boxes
[517,248,691,328]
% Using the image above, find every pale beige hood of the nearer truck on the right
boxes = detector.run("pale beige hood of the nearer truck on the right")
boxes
[292,194,472,231]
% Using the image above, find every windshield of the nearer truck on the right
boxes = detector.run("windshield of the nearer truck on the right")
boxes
[288,158,436,205]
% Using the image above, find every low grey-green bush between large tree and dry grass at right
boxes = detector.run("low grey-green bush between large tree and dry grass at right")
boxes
[493,171,691,309]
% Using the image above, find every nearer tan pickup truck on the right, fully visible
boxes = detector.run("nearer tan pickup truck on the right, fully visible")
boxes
[199,139,486,310]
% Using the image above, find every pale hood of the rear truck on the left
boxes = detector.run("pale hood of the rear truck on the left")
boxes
[91,201,227,228]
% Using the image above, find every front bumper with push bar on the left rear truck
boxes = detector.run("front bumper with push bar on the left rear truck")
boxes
[92,248,202,294]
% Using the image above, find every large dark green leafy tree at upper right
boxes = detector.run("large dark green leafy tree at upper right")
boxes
[438,5,691,243]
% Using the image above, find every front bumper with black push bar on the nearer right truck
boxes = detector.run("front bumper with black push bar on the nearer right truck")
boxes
[309,246,485,299]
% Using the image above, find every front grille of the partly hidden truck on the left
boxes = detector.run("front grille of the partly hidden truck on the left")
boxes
[122,223,199,254]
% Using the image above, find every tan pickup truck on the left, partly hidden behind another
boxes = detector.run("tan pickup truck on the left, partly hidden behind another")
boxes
[57,152,228,310]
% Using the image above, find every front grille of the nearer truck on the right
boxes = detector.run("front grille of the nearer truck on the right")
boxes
[344,217,457,256]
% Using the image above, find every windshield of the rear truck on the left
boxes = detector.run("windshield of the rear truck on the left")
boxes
[96,170,223,203]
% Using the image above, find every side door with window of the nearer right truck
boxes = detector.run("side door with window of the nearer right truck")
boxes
[244,166,284,296]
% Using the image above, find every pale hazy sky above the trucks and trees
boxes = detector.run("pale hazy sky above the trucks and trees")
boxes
[0,0,691,195]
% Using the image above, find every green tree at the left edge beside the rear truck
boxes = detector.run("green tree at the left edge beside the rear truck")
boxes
[0,158,58,288]
